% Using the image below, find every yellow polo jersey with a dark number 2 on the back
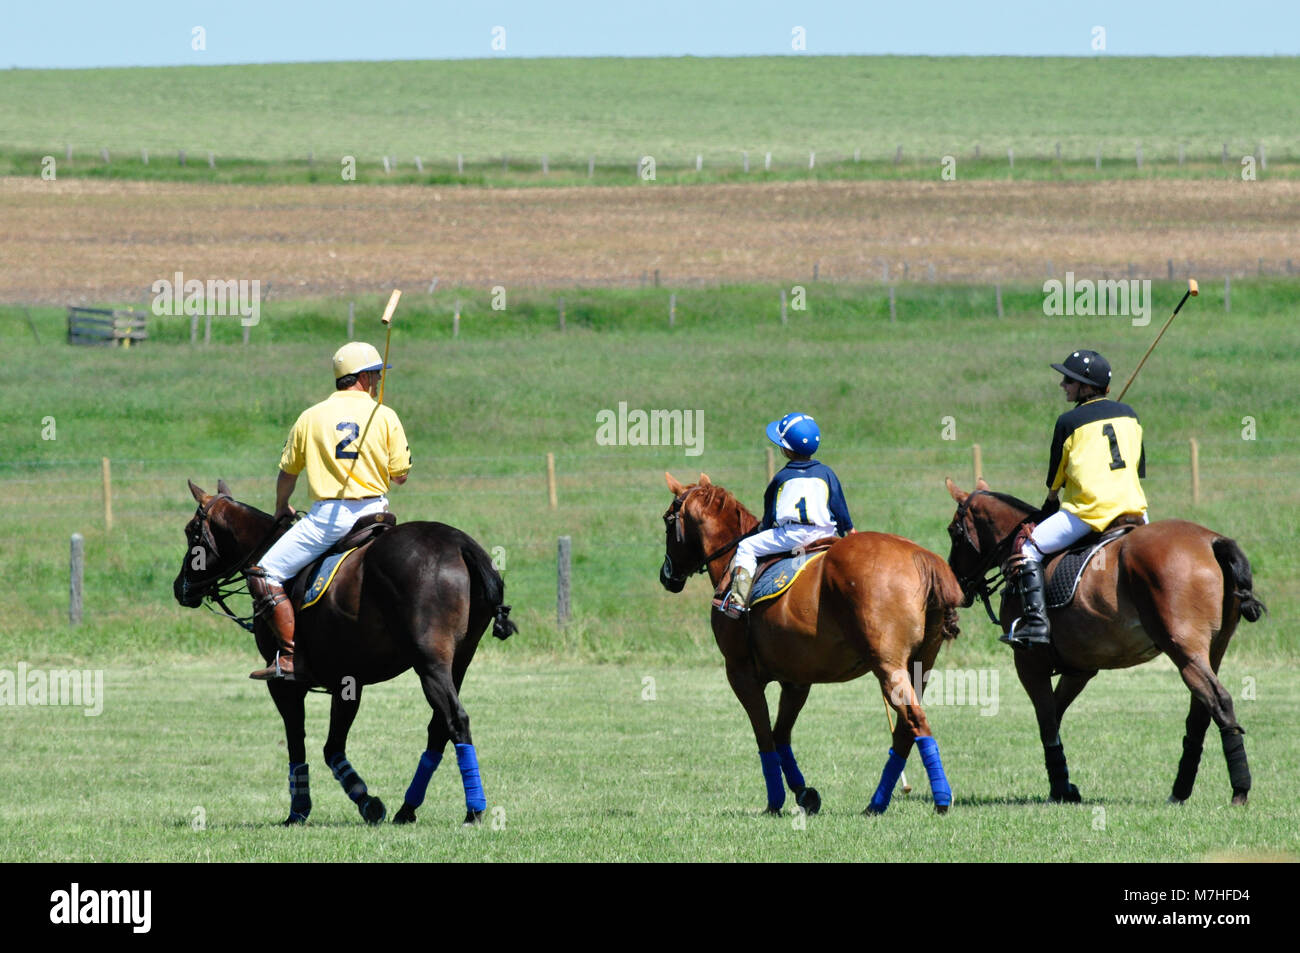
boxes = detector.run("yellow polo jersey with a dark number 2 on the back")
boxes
[280,390,411,502]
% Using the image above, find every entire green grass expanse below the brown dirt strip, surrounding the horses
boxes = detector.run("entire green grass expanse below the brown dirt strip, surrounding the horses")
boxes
[0,280,1300,861]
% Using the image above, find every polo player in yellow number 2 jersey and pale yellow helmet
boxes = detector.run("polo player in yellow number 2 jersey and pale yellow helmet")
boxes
[247,341,411,680]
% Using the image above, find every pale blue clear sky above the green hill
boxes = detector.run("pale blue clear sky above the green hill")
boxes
[0,0,1300,68]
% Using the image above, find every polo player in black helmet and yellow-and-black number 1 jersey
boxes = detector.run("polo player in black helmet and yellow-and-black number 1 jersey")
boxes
[1001,351,1147,645]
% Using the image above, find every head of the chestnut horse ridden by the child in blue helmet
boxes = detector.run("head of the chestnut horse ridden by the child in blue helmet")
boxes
[659,473,757,593]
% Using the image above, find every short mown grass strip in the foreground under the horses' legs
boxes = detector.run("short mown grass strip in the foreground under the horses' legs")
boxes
[0,655,1300,862]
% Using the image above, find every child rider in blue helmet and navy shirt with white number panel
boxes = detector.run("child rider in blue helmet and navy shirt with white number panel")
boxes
[719,413,853,619]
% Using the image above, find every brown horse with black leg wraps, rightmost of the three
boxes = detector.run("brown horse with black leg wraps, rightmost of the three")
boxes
[946,480,1266,805]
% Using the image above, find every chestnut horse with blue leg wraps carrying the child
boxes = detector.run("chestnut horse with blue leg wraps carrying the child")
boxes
[659,473,962,814]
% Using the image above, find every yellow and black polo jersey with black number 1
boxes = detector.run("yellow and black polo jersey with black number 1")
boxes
[1048,398,1147,530]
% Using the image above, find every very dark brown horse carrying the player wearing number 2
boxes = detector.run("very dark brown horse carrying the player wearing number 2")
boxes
[173,480,517,826]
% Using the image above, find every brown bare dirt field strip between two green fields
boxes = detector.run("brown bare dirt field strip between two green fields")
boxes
[0,178,1300,304]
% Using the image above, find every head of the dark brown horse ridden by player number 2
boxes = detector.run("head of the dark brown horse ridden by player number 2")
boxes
[172,480,269,608]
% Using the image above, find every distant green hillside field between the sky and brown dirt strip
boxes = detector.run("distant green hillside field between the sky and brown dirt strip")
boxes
[0,56,1300,185]
